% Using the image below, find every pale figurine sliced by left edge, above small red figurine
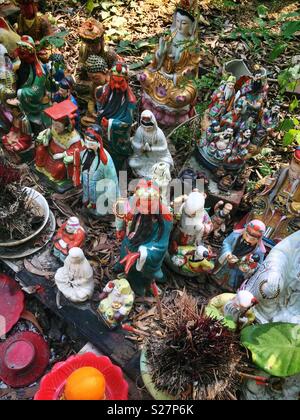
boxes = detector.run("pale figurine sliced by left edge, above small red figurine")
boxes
[0,44,16,134]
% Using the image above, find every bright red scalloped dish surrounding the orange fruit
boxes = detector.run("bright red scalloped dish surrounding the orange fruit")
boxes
[34,353,128,401]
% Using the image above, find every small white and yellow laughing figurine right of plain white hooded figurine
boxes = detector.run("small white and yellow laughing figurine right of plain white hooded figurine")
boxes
[98,279,134,328]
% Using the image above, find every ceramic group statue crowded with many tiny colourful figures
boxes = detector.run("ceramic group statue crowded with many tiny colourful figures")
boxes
[198,64,278,191]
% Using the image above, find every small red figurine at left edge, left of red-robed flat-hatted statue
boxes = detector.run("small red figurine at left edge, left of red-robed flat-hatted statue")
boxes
[2,100,32,153]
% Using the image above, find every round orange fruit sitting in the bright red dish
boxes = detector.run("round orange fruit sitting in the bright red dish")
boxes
[64,367,105,401]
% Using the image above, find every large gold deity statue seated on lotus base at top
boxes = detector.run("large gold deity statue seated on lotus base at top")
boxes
[139,0,200,126]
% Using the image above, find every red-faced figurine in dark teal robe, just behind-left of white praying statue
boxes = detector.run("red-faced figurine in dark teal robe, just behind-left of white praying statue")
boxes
[96,63,136,171]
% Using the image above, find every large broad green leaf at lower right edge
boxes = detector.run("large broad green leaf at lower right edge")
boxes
[241,322,300,378]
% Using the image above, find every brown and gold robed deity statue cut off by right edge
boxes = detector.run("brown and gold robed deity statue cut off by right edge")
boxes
[241,147,300,245]
